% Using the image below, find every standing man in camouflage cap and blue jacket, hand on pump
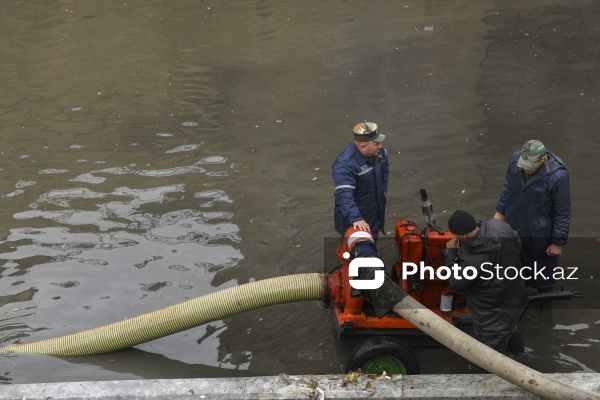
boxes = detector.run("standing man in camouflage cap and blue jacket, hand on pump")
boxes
[332,122,390,239]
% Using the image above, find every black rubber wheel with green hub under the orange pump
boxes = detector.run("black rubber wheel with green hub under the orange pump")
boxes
[346,336,421,375]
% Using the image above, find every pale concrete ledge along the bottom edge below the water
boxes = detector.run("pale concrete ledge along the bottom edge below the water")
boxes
[0,373,600,400]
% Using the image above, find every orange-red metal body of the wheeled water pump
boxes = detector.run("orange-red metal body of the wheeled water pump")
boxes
[328,220,469,345]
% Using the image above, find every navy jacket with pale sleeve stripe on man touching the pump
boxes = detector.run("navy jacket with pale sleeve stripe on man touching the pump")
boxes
[331,141,390,236]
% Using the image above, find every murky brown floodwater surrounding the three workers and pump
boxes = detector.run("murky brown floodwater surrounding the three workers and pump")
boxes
[0,0,600,383]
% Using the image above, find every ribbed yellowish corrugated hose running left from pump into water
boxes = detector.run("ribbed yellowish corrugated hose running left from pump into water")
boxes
[0,273,326,355]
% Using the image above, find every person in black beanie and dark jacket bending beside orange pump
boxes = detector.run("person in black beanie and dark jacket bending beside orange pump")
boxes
[443,210,527,352]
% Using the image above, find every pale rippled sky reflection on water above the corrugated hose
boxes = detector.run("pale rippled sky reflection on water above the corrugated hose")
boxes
[0,162,243,372]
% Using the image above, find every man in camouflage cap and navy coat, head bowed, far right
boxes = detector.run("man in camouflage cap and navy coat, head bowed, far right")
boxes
[494,140,571,289]
